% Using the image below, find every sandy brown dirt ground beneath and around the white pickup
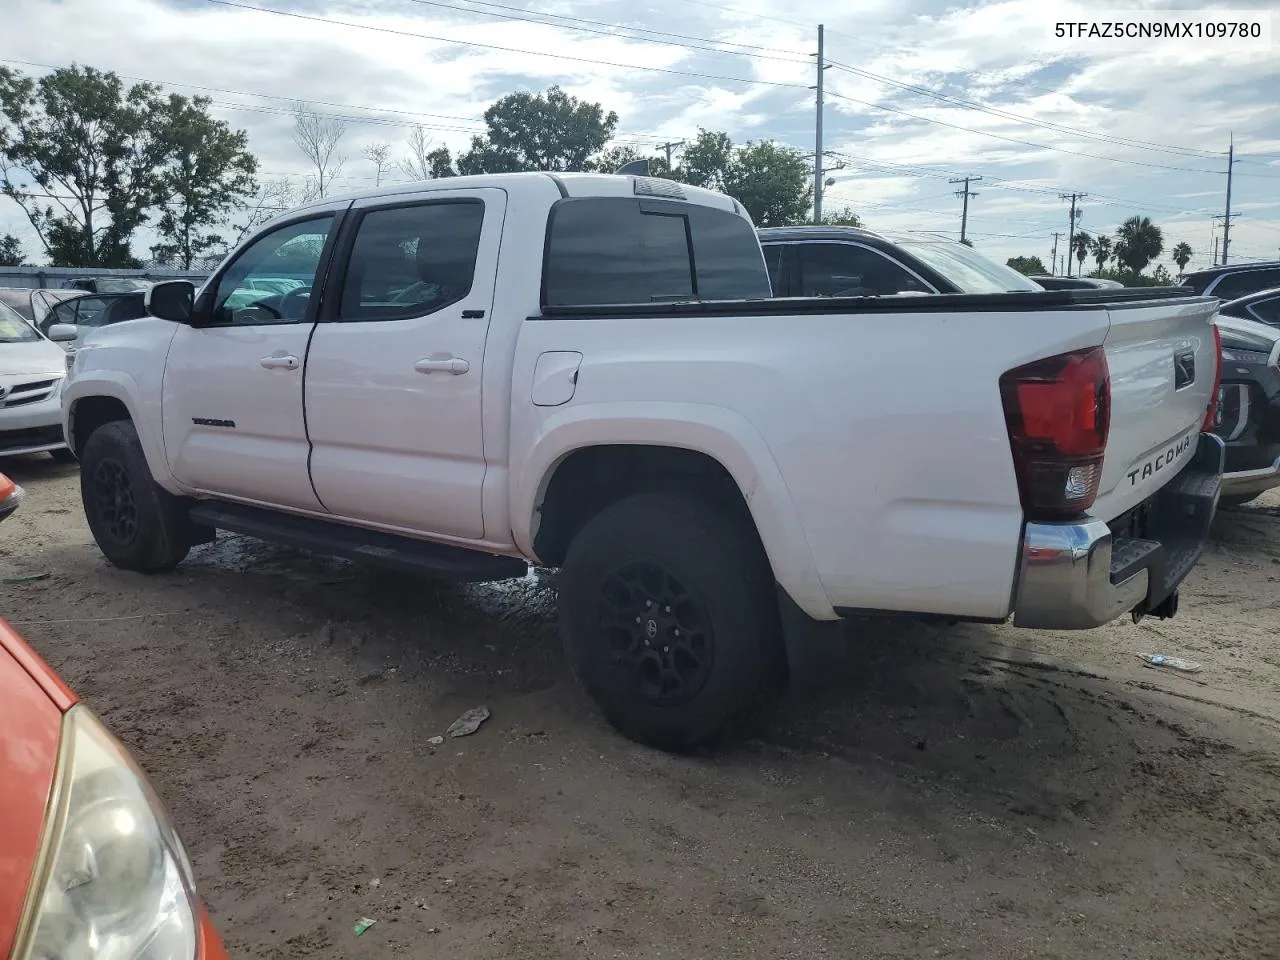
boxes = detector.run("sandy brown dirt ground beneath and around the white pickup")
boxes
[0,458,1280,960]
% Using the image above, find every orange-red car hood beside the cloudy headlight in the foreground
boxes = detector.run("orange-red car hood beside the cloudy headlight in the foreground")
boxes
[0,620,76,956]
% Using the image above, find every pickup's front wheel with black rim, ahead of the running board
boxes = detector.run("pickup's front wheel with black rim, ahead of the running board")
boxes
[81,420,192,573]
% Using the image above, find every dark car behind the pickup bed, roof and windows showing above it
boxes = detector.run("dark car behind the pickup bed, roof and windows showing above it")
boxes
[759,227,1044,297]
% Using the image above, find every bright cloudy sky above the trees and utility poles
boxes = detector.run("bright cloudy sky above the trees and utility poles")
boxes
[0,0,1280,269]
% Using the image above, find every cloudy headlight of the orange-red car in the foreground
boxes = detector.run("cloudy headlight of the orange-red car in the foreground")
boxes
[13,705,198,960]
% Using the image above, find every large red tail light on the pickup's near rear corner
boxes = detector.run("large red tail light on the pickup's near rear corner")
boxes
[1000,347,1111,520]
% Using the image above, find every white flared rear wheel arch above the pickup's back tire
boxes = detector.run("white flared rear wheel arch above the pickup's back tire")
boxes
[512,403,836,620]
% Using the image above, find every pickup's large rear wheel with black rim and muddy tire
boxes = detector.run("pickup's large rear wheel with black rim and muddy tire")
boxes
[558,494,786,750]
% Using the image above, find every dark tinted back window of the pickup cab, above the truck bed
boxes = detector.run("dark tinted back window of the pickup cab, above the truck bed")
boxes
[543,197,771,306]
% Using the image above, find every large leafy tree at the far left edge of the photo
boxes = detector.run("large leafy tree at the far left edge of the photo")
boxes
[0,64,163,268]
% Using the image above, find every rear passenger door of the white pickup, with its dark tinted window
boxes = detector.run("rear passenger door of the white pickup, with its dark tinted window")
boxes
[306,188,507,540]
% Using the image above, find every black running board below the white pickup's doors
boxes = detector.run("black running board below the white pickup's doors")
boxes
[191,500,529,582]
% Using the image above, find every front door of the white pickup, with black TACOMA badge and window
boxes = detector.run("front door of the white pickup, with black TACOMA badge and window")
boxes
[163,210,339,511]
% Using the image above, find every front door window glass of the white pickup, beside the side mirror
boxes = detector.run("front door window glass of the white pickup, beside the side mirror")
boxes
[211,214,333,326]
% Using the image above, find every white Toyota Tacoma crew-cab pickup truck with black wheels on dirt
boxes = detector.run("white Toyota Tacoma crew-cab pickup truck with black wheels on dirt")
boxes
[63,174,1222,748]
